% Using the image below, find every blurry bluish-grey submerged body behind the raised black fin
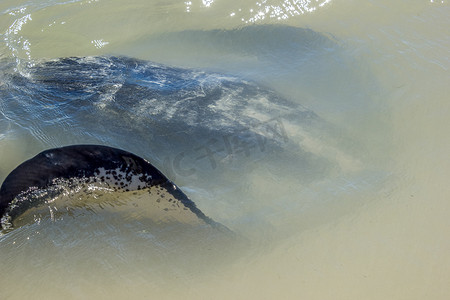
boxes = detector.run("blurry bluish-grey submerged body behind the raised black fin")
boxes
[0,53,358,232]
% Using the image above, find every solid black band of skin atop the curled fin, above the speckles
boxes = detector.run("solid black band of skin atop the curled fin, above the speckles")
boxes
[0,145,216,225]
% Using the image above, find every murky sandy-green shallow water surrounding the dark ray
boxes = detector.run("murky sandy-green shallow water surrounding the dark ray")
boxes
[0,0,450,299]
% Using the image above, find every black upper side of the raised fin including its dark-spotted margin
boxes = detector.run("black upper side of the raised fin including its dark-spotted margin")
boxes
[0,145,218,227]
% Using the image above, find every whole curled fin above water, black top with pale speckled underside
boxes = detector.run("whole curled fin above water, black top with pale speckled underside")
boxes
[0,145,228,231]
